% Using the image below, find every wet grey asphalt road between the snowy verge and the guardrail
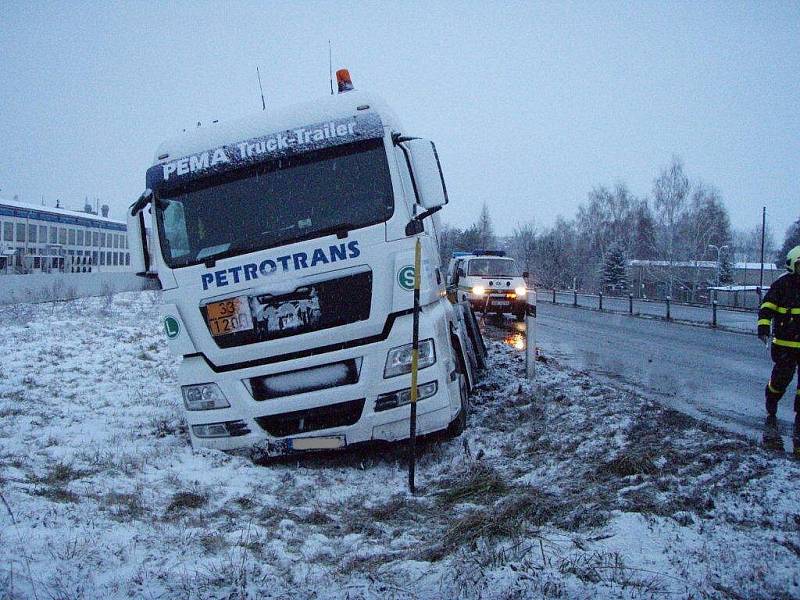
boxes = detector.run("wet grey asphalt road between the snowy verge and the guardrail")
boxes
[489,302,794,442]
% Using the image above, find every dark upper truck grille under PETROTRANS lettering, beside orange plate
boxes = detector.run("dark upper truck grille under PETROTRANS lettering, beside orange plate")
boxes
[200,271,372,348]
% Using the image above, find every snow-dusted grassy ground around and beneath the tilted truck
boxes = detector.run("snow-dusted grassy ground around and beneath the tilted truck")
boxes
[0,292,800,599]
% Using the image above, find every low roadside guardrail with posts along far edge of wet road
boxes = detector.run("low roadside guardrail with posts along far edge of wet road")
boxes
[537,289,758,333]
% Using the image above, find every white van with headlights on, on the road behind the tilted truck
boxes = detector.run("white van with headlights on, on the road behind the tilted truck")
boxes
[447,250,528,321]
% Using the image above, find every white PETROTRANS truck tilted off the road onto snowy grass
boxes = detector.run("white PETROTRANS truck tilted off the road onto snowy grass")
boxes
[128,71,480,454]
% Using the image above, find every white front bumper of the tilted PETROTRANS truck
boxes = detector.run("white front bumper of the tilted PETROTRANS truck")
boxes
[178,305,460,455]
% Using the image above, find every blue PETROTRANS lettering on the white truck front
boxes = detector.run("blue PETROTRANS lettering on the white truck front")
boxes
[200,240,361,290]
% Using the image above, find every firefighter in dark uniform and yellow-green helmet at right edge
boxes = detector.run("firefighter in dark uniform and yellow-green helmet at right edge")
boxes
[758,246,800,452]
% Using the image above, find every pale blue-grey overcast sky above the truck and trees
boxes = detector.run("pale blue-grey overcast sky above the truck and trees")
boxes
[0,0,800,241]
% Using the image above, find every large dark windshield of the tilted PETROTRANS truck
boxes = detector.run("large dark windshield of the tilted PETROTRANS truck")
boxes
[155,139,394,268]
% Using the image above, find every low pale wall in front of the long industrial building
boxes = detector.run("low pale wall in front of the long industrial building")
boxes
[0,272,158,304]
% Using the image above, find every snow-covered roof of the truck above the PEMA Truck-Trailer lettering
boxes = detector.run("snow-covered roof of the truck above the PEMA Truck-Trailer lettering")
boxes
[148,90,401,165]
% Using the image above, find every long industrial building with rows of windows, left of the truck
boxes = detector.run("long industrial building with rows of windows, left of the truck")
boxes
[0,199,130,274]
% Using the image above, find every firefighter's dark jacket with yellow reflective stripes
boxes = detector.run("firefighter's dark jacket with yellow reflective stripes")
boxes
[758,273,800,349]
